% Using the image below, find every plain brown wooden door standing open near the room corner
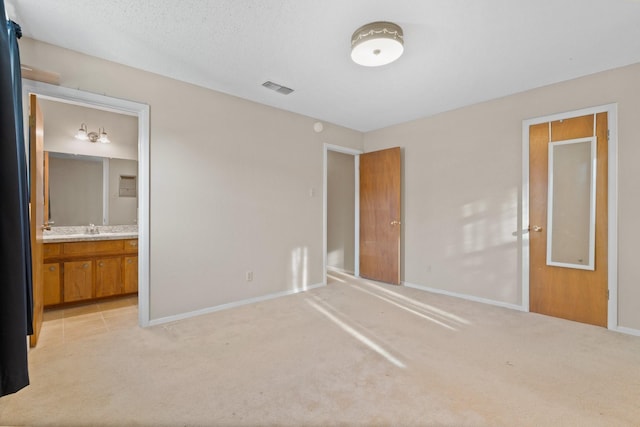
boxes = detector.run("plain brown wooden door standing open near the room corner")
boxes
[360,147,401,285]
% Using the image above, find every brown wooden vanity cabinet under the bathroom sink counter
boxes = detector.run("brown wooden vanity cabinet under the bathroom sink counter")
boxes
[44,239,138,306]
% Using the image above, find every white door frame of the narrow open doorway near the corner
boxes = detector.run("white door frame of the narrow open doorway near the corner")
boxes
[322,143,362,285]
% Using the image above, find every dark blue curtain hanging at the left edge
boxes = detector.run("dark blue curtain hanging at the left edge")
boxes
[0,0,33,396]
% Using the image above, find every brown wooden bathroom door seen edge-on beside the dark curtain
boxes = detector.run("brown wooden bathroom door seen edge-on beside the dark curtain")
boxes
[29,95,44,347]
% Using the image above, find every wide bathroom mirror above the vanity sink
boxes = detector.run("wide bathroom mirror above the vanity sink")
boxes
[45,152,138,226]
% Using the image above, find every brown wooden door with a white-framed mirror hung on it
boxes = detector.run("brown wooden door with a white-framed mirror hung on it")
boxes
[529,113,608,326]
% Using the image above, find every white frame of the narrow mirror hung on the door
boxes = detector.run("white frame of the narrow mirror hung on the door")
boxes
[547,136,598,270]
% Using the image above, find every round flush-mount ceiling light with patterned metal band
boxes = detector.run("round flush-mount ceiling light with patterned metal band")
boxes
[351,21,404,67]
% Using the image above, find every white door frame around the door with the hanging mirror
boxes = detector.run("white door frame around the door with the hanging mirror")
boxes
[520,104,618,329]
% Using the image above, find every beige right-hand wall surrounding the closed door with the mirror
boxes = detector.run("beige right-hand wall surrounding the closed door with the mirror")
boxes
[364,64,640,330]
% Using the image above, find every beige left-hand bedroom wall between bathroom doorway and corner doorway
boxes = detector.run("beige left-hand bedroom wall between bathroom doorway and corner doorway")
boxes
[20,38,362,320]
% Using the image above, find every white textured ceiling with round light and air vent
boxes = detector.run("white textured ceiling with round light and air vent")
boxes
[5,0,640,131]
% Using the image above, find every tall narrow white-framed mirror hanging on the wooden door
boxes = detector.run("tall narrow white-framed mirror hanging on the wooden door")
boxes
[547,137,597,270]
